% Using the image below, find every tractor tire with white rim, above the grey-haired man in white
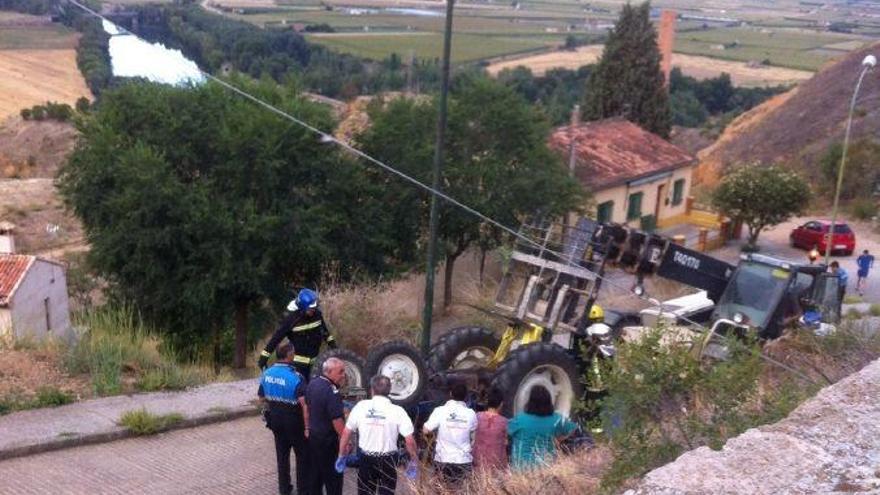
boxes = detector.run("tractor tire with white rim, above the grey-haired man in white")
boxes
[365,340,428,407]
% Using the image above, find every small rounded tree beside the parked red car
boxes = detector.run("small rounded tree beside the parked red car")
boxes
[712,163,810,249]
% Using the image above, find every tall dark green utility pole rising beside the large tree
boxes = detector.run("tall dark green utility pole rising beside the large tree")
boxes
[422,0,455,356]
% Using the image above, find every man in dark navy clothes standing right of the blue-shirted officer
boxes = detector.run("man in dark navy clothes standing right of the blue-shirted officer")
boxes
[306,357,345,495]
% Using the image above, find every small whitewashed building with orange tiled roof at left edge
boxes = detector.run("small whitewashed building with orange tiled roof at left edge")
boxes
[0,253,71,342]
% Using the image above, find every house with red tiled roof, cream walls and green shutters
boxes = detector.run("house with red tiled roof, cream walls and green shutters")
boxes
[549,118,697,230]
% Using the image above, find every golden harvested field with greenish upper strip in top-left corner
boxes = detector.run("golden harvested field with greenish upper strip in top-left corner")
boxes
[0,13,91,120]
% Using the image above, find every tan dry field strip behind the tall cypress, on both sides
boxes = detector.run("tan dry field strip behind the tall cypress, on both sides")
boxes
[486,45,813,86]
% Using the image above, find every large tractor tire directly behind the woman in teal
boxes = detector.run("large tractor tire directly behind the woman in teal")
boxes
[492,342,584,416]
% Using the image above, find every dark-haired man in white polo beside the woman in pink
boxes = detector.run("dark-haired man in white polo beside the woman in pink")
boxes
[424,383,477,484]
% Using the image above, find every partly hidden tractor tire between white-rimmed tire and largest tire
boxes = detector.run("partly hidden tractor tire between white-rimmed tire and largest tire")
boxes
[428,327,501,372]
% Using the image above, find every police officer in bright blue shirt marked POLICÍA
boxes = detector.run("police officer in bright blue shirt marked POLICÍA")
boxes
[257,343,309,495]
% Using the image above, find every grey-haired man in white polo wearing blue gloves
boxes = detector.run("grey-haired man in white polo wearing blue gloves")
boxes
[339,375,418,495]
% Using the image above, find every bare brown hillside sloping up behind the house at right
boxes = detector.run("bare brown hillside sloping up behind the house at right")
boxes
[698,43,880,183]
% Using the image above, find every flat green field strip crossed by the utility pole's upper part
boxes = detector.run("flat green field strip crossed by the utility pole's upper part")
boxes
[308,33,553,63]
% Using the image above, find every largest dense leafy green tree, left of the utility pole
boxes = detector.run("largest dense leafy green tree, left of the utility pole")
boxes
[59,80,390,367]
